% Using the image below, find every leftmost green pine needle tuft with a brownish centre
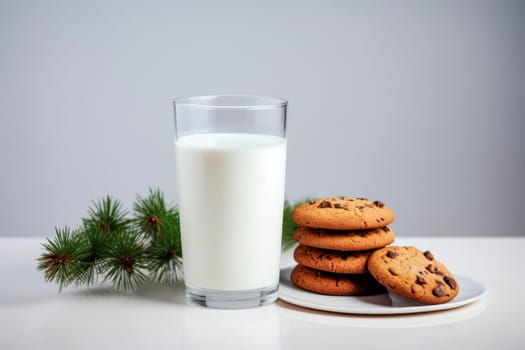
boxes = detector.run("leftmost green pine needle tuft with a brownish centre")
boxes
[38,227,87,291]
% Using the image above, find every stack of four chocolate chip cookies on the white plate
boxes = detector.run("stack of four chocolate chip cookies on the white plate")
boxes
[291,197,394,295]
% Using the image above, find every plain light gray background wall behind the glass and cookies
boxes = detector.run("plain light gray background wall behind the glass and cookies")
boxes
[0,0,525,236]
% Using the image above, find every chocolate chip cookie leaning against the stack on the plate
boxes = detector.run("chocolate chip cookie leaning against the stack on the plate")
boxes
[367,246,459,304]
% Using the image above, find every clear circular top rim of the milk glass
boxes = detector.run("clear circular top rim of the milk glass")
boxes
[173,95,288,110]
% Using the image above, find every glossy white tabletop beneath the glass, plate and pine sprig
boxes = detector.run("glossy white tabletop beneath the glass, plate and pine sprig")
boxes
[0,237,525,350]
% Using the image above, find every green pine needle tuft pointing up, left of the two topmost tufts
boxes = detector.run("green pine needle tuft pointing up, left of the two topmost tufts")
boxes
[82,196,129,233]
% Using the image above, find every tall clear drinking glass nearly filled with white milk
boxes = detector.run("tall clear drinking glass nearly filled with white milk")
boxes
[174,95,287,309]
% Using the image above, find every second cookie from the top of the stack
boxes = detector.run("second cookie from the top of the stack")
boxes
[294,226,395,251]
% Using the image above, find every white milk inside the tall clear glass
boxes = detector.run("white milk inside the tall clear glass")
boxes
[175,134,286,291]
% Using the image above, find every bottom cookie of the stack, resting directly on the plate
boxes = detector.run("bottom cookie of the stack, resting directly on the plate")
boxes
[290,265,385,295]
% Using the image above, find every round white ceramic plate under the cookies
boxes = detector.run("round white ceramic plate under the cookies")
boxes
[279,266,485,315]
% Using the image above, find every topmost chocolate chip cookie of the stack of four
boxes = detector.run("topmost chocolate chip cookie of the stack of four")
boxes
[292,197,394,230]
